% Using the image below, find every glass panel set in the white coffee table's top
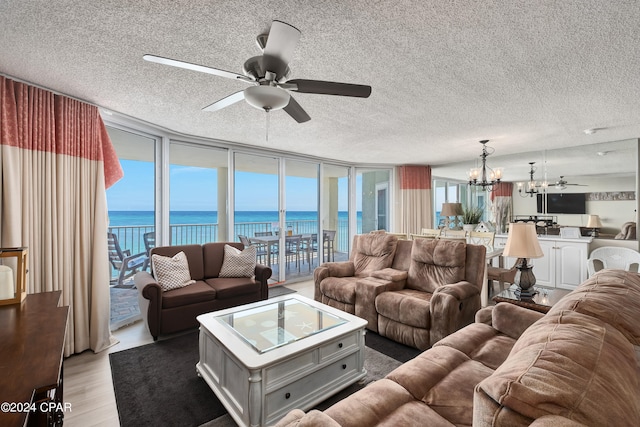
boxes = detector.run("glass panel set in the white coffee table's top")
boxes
[216,298,347,353]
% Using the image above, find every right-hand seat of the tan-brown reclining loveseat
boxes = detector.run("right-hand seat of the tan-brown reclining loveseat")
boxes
[374,239,486,350]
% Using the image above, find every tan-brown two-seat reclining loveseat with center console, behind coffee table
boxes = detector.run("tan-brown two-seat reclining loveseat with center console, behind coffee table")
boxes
[314,232,486,350]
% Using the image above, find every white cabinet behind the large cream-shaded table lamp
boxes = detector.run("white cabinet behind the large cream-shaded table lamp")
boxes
[495,235,592,289]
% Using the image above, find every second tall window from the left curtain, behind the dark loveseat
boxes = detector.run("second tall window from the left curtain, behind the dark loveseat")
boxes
[169,141,228,245]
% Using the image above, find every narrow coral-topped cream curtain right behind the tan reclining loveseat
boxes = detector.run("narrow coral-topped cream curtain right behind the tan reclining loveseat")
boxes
[396,165,433,234]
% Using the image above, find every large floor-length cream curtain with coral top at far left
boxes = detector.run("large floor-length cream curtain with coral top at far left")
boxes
[0,76,122,356]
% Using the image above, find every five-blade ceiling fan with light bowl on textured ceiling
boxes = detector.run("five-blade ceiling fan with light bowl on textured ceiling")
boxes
[143,21,371,123]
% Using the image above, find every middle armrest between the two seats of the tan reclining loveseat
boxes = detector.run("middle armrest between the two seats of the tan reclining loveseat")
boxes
[355,274,407,332]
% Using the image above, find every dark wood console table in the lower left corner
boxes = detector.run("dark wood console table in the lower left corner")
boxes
[0,291,69,426]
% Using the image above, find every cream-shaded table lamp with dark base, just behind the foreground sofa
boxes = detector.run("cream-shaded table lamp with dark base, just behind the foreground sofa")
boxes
[502,222,544,298]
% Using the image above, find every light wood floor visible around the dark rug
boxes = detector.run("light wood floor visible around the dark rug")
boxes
[64,281,313,427]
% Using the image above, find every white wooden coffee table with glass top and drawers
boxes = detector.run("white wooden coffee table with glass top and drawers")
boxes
[196,294,367,426]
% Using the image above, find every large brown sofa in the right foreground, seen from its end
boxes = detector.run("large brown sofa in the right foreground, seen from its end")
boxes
[277,270,640,427]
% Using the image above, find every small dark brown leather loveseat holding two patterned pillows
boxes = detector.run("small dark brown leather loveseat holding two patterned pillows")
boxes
[135,242,271,340]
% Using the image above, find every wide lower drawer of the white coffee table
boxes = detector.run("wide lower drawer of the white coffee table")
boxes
[265,352,359,424]
